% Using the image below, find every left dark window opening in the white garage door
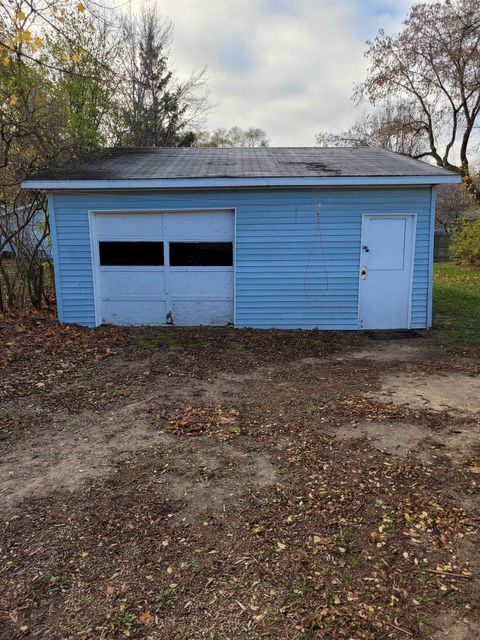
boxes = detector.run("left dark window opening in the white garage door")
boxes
[99,242,164,267]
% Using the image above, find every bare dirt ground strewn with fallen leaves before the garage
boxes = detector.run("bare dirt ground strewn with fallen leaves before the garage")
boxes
[0,320,480,640]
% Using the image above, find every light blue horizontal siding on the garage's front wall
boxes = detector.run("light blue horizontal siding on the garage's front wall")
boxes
[53,187,432,329]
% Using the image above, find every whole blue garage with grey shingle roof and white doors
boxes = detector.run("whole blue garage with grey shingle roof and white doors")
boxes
[23,148,460,330]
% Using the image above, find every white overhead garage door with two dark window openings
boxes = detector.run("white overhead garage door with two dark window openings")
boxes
[92,211,234,326]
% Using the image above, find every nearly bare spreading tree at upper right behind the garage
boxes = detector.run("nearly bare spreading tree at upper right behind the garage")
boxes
[356,0,480,202]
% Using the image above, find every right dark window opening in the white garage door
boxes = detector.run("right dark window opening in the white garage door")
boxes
[170,242,233,267]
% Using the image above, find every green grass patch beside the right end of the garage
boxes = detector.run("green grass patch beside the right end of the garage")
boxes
[433,262,480,350]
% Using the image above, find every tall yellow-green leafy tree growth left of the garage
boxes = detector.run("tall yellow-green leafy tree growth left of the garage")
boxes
[0,0,120,309]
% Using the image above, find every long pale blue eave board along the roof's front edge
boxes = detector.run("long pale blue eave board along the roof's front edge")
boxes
[21,173,461,191]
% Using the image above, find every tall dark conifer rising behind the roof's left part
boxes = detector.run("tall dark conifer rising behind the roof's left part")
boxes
[119,7,207,147]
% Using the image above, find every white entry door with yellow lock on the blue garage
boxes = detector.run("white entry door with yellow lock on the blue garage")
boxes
[359,215,415,329]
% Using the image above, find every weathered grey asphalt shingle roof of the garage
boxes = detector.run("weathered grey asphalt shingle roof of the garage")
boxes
[30,147,451,180]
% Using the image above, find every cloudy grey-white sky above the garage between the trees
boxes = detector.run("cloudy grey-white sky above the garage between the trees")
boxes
[129,0,418,146]
